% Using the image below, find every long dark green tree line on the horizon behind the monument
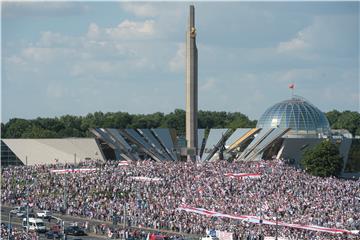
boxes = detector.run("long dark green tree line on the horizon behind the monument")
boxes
[1,109,360,138]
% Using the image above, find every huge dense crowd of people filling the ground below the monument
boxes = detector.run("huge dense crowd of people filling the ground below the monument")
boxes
[1,160,360,239]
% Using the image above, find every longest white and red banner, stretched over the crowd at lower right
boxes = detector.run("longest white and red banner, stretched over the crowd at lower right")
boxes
[177,205,359,235]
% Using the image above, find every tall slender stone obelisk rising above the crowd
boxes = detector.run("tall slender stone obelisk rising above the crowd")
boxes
[186,5,198,160]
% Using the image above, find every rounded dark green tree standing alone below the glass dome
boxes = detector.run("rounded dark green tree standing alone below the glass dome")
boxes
[301,140,343,177]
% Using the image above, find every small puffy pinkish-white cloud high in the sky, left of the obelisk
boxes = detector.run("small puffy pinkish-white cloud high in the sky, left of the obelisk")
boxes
[105,20,155,39]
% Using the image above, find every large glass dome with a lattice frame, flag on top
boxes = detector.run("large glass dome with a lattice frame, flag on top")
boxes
[256,96,330,134]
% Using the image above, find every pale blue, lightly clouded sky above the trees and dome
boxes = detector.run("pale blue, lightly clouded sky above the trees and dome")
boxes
[1,2,360,122]
